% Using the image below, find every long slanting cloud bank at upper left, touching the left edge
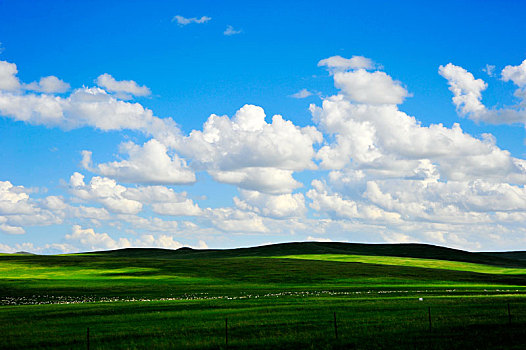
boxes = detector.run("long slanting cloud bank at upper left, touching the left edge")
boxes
[0,61,180,146]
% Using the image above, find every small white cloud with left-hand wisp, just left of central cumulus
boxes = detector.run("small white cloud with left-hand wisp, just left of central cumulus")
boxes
[82,139,196,184]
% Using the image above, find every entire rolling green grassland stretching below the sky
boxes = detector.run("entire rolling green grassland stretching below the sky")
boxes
[0,243,526,349]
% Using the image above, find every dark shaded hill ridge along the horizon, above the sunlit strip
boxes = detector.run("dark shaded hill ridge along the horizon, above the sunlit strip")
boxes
[84,242,526,268]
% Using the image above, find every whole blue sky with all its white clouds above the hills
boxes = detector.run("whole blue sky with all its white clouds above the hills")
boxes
[0,0,526,254]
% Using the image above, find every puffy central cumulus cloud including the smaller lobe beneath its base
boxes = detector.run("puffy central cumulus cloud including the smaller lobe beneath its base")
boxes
[177,105,322,193]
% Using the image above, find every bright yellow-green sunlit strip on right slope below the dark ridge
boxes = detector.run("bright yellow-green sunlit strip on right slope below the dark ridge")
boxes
[273,254,526,275]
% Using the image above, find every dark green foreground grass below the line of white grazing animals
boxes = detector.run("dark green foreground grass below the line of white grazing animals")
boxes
[0,296,526,349]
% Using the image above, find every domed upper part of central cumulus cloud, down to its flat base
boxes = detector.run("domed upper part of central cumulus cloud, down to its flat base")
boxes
[179,105,322,171]
